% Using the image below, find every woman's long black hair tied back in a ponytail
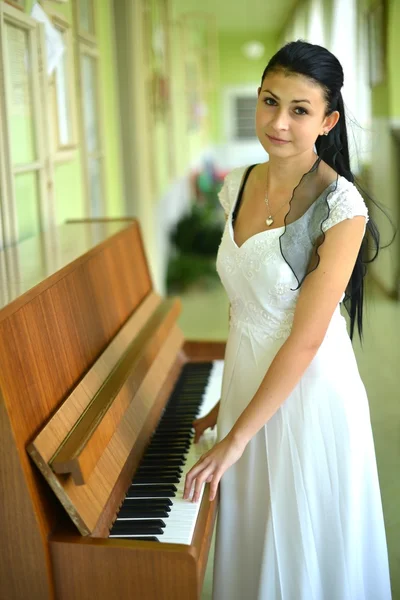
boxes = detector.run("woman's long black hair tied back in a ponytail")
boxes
[261,40,394,342]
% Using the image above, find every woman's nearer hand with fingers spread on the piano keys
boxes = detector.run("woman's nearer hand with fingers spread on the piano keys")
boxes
[183,434,246,502]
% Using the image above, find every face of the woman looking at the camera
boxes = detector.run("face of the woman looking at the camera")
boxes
[256,72,339,158]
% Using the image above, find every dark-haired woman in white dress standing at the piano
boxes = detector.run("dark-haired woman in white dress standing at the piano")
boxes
[184,41,391,600]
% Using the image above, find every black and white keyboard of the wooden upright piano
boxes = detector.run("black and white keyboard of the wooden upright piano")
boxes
[109,360,224,545]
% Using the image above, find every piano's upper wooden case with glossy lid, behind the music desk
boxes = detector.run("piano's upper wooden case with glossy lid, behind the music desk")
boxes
[0,220,152,600]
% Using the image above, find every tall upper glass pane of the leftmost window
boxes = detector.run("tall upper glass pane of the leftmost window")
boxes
[5,23,37,165]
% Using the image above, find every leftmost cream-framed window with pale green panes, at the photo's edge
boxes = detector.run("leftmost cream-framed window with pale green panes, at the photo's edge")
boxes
[0,2,54,246]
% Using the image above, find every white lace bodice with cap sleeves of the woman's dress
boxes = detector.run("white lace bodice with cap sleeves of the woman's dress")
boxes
[217,167,368,339]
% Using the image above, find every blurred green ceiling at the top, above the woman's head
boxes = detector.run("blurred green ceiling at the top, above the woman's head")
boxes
[172,0,298,33]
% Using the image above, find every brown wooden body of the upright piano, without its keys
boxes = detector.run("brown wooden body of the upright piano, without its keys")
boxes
[0,219,225,600]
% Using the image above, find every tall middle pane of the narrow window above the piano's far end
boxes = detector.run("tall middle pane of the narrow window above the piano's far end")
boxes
[82,54,99,153]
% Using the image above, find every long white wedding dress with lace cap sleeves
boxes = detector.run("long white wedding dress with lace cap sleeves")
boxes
[213,168,391,600]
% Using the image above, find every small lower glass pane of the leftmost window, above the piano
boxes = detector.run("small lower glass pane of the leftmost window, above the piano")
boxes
[14,171,40,241]
